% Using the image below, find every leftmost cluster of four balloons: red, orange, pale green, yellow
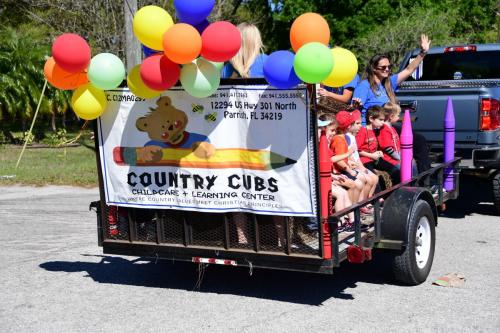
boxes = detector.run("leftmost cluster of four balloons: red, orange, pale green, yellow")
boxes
[44,33,125,120]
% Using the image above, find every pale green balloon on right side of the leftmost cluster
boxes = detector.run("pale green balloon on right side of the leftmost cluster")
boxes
[87,53,125,90]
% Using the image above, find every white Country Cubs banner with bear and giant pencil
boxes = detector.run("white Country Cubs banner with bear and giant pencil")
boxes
[98,85,316,216]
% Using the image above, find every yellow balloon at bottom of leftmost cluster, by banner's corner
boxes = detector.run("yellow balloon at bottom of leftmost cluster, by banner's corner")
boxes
[71,83,108,120]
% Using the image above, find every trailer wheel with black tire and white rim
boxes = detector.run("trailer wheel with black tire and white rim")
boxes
[392,200,436,285]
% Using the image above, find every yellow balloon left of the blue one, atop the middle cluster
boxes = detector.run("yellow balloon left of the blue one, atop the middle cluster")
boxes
[133,6,174,51]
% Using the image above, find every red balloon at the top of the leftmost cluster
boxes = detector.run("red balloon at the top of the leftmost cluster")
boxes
[52,34,90,73]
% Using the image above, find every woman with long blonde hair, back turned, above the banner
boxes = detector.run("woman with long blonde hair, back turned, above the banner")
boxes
[221,23,267,78]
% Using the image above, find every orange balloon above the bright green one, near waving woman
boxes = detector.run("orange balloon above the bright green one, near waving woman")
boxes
[290,13,330,52]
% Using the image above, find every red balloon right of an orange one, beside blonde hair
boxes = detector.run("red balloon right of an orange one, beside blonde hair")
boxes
[201,21,241,62]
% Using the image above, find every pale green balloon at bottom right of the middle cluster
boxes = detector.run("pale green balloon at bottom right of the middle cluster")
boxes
[180,58,220,98]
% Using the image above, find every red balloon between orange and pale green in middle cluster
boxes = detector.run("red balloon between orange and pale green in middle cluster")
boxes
[141,54,181,91]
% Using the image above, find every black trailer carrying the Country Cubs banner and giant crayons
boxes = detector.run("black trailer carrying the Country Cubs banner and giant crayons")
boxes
[91,79,459,285]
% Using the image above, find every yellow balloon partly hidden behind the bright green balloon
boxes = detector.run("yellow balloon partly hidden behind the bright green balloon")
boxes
[321,47,358,88]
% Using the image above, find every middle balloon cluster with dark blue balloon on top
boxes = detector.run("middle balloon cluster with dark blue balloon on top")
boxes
[127,0,241,98]
